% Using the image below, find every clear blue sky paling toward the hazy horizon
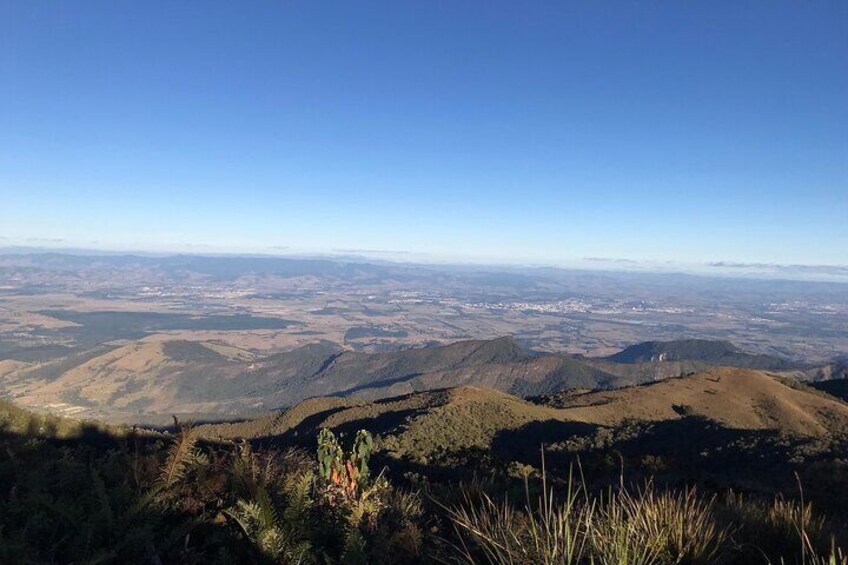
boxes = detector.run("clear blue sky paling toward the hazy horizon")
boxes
[0,0,848,264]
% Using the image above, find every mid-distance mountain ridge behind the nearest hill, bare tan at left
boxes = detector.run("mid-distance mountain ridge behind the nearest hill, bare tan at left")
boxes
[0,337,845,421]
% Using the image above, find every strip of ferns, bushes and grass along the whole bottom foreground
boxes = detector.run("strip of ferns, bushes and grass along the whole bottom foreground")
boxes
[0,407,848,564]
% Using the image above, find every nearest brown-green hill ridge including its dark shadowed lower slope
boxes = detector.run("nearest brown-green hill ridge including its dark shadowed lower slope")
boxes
[201,368,848,486]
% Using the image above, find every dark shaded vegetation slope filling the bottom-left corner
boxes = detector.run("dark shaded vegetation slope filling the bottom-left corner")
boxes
[0,417,255,564]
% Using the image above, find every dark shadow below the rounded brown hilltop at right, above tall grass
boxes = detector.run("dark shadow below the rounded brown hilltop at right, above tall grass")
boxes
[492,416,848,511]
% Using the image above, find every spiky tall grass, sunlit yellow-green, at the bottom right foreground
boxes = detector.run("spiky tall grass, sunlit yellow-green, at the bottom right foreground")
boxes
[447,468,848,565]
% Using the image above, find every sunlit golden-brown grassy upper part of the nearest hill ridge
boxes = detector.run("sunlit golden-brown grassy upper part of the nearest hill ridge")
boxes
[201,368,848,463]
